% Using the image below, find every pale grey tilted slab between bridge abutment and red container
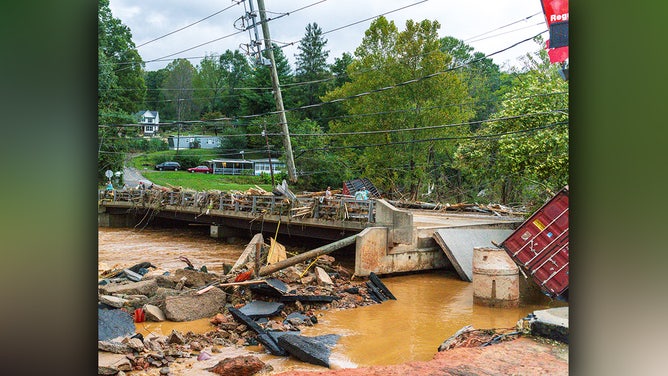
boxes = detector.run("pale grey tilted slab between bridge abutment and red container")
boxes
[433,228,513,282]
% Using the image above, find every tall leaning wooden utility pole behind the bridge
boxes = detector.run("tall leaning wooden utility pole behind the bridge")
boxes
[256,0,297,183]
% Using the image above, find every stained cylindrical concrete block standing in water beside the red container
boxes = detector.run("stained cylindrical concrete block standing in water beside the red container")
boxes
[473,247,520,308]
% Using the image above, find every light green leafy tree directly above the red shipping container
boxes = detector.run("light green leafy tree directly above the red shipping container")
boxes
[457,39,569,206]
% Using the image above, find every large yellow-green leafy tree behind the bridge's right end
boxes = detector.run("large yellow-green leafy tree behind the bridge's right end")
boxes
[324,17,473,200]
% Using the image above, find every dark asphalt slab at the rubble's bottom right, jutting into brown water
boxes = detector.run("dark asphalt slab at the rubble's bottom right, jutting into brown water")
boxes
[278,334,338,368]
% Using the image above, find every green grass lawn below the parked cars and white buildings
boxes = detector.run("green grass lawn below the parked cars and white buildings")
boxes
[140,169,273,192]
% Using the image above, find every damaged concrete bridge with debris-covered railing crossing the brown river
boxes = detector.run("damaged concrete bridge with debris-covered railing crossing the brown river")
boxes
[98,191,523,276]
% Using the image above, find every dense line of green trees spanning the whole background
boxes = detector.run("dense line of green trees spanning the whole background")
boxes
[98,0,568,209]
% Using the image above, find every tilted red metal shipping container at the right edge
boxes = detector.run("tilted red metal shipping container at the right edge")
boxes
[501,187,569,297]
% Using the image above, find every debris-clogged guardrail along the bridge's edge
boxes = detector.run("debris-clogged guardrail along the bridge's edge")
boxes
[98,189,376,222]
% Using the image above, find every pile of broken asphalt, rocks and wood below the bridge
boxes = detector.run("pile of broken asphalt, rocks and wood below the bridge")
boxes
[98,234,395,375]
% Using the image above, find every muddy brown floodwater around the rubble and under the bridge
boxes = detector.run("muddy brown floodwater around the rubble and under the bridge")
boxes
[98,228,564,375]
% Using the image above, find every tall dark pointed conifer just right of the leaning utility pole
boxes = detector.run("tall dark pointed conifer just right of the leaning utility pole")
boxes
[292,22,331,124]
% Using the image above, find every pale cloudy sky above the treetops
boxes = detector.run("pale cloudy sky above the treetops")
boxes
[110,0,548,71]
